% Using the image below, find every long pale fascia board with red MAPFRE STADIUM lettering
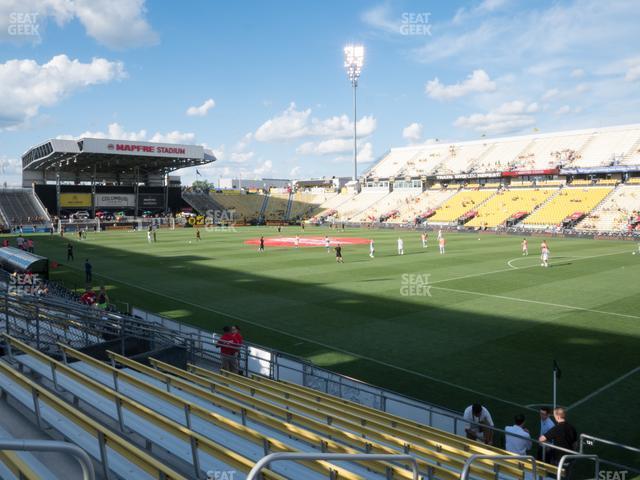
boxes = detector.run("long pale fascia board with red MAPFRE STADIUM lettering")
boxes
[82,138,204,159]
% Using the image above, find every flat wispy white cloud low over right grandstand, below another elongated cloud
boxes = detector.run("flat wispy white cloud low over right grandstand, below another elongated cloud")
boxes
[454,100,539,134]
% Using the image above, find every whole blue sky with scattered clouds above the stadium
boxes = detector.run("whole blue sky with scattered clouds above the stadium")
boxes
[0,0,640,184]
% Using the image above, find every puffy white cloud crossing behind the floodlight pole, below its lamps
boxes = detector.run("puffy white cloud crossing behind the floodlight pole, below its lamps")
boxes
[254,103,377,142]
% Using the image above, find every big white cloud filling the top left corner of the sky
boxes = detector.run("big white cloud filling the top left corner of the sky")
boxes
[0,0,158,49]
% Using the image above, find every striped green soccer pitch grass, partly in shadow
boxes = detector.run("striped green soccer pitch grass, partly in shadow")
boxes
[13,227,640,454]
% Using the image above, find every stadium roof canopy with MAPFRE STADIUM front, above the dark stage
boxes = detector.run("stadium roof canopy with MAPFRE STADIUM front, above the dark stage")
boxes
[22,138,216,175]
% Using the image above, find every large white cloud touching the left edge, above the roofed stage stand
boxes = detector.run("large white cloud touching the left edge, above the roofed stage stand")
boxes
[0,55,126,128]
